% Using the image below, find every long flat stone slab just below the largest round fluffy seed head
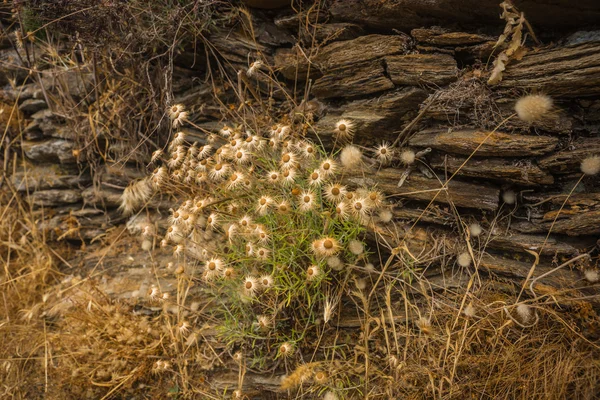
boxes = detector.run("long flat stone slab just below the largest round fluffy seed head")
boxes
[409,129,558,157]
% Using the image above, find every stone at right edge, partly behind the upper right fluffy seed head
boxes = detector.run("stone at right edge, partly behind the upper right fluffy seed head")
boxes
[539,137,600,174]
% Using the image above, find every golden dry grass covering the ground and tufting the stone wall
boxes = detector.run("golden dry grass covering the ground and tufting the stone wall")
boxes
[0,1,600,399]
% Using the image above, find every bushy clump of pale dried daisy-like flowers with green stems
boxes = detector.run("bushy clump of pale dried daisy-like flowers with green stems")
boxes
[122,101,384,396]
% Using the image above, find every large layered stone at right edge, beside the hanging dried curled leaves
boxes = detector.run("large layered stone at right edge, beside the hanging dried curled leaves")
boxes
[498,37,600,97]
